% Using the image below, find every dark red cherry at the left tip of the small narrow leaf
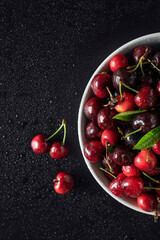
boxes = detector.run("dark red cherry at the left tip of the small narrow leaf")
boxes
[97,108,117,130]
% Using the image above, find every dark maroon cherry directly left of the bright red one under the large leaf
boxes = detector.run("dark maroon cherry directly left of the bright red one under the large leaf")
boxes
[113,145,135,165]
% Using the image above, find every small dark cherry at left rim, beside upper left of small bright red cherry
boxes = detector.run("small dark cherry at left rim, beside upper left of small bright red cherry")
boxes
[86,121,103,139]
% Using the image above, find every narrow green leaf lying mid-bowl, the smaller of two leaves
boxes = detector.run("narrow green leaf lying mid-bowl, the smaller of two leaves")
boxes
[113,110,147,121]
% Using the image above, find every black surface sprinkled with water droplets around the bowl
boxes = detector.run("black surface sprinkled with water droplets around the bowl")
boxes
[0,0,160,240]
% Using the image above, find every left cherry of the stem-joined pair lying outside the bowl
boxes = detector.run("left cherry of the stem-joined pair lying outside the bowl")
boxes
[31,134,50,154]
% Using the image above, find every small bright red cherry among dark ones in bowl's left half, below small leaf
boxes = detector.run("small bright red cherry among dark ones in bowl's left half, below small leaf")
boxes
[101,129,120,147]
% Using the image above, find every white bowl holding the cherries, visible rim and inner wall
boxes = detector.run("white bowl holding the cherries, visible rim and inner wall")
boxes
[78,33,160,215]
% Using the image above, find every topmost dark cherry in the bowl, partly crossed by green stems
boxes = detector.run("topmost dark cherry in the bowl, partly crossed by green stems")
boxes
[132,46,152,64]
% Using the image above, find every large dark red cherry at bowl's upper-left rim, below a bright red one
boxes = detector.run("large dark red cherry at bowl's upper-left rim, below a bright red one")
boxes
[91,73,113,98]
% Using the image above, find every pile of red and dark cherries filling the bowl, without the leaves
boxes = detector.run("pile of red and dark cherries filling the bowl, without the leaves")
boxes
[84,46,160,217]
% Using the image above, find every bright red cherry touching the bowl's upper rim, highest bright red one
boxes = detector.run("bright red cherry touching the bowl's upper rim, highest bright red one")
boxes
[109,53,128,72]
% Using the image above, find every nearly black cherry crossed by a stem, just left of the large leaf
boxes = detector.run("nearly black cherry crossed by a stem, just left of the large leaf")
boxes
[124,127,143,147]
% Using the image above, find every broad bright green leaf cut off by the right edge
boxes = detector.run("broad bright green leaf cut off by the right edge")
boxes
[133,126,160,150]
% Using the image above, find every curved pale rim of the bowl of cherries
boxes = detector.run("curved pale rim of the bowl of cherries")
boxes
[78,32,160,215]
